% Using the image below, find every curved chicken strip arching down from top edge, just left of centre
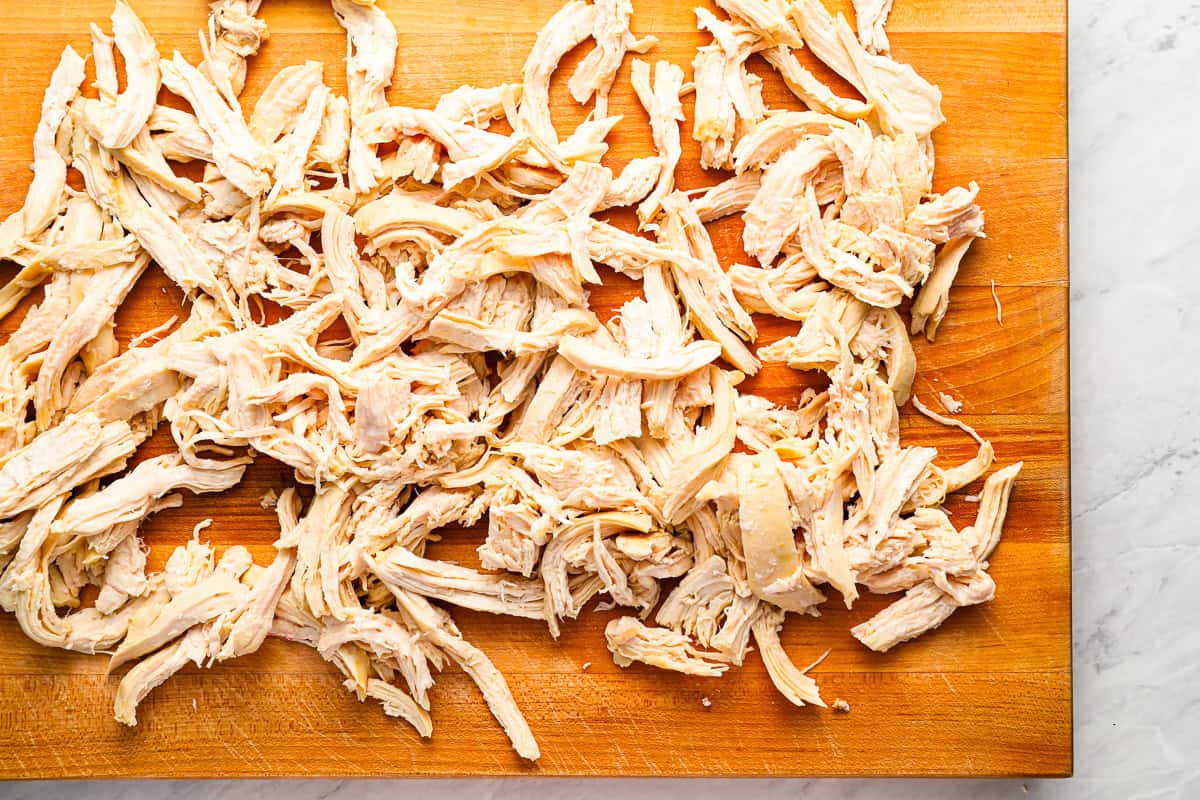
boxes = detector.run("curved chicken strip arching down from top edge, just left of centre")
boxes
[515,0,597,148]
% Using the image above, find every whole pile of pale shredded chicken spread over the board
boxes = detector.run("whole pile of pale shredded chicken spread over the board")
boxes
[0,0,1020,759]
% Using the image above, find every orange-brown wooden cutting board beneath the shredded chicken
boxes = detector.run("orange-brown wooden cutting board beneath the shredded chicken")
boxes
[0,0,1072,778]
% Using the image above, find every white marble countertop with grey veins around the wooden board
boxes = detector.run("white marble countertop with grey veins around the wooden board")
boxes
[0,0,1200,800]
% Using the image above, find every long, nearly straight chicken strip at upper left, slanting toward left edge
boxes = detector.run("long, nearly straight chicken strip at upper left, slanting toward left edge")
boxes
[0,47,85,260]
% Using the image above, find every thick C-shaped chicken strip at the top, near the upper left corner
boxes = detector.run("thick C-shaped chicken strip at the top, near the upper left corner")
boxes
[79,0,160,150]
